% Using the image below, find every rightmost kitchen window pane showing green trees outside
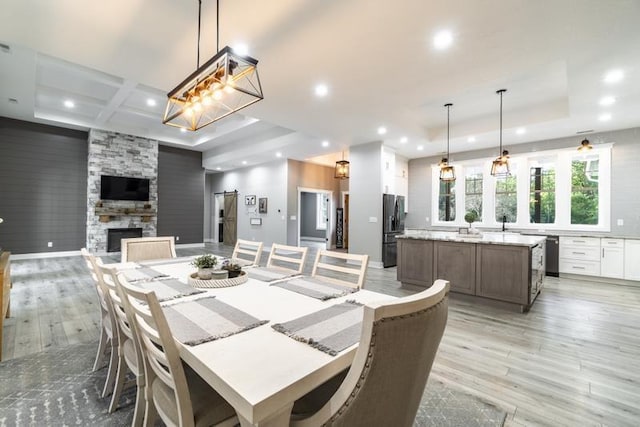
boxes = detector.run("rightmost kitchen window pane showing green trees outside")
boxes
[571,155,600,225]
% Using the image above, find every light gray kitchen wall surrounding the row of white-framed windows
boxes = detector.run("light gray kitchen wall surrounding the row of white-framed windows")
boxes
[408,128,640,237]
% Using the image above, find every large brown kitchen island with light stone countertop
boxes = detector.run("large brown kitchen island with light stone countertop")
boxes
[397,231,545,311]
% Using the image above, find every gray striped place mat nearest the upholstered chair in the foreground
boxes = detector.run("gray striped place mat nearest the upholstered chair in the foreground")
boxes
[271,301,363,356]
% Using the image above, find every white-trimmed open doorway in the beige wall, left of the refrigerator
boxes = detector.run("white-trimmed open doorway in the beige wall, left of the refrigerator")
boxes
[298,187,333,249]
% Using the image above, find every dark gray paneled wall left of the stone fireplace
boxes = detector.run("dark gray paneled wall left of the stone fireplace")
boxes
[0,117,87,254]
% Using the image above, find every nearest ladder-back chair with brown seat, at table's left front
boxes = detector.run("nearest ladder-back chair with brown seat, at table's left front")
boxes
[118,273,237,426]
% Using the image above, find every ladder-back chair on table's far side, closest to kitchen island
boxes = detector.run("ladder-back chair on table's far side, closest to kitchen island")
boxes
[311,249,369,289]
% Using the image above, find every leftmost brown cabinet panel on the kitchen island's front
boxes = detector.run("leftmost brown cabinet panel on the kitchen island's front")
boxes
[396,239,433,288]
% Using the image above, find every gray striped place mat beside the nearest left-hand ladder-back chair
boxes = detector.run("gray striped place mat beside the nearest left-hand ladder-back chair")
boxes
[163,297,269,346]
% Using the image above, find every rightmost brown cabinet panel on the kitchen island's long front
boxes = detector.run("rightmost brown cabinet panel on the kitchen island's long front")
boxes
[476,244,530,306]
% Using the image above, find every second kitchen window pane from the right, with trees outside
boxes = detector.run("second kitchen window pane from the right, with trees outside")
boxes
[529,163,556,224]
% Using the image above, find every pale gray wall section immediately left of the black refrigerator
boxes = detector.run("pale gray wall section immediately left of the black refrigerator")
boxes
[349,142,382,266]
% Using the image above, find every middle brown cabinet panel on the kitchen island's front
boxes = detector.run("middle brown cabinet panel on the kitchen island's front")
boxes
[433,242,476,295]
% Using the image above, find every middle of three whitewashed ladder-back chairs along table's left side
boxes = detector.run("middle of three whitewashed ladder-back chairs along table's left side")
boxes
[98,264,146,426]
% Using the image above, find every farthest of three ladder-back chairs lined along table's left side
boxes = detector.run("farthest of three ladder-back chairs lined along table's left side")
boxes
[80,248,119,397]
